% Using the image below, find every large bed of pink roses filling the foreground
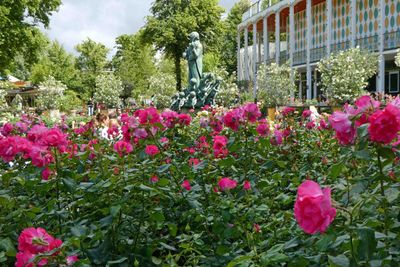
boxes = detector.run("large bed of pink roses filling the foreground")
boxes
[0,99,400,266]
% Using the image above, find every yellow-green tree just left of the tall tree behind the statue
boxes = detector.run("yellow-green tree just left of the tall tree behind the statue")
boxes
[112,32,156,98]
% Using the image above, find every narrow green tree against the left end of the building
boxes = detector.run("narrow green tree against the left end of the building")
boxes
[220,0,251,74]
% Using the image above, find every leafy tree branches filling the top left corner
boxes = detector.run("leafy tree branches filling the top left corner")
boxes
[0,0,61,72]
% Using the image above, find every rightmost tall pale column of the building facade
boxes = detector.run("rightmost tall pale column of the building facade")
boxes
[377,0,385,93]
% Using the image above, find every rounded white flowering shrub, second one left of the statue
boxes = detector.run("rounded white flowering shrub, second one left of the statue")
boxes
[93,73,124,108]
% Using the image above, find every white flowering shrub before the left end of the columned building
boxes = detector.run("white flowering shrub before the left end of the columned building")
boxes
[257,63,297,107]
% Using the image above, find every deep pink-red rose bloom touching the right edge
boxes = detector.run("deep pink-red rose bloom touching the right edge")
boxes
[368,104,400,144]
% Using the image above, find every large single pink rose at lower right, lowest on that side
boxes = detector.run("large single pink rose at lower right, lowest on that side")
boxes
[294,180,336,234]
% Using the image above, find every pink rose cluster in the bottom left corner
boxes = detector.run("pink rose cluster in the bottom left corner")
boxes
[15,227,78,267]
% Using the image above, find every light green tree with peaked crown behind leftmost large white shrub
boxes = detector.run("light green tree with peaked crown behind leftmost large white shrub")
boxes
[30,41,79,90]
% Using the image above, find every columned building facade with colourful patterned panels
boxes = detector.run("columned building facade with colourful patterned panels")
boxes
[237,0,400,99]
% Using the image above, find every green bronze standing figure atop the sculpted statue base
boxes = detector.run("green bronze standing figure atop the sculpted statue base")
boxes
[183,32,203,87]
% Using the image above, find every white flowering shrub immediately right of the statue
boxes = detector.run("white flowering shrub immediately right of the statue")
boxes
[213,69,240,108]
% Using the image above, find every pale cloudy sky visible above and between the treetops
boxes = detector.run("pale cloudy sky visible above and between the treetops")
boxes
[45,0,236,55]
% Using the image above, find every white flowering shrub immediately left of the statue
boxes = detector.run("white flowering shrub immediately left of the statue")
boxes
[146,73,176,109]
